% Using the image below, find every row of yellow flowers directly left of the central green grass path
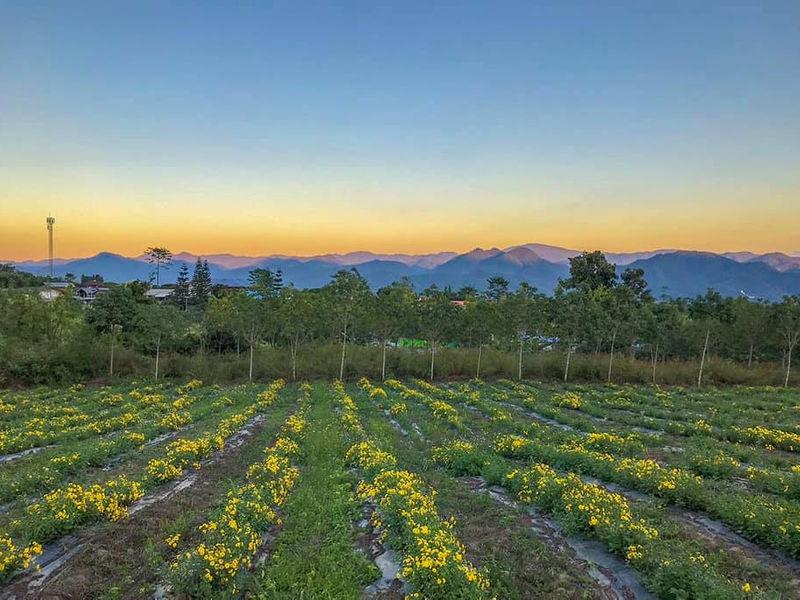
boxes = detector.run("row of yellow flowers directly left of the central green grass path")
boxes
[167,400,306,598]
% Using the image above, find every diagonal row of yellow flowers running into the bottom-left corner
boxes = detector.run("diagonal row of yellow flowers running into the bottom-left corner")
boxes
[0,380,284,580]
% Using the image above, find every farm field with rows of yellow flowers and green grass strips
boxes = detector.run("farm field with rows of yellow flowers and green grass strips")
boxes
[0,379,800,600]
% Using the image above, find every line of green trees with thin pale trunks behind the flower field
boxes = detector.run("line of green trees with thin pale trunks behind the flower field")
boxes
[0,248,800,386]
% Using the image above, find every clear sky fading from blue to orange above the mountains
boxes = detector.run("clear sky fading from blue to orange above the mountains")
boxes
[0,0,800,259]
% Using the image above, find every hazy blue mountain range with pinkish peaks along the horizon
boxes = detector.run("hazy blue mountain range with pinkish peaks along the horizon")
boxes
[12,244,800,300]
